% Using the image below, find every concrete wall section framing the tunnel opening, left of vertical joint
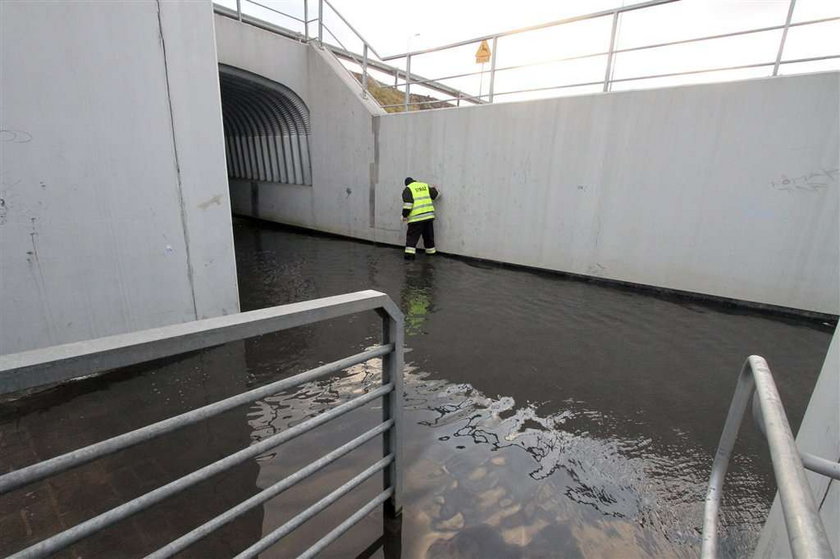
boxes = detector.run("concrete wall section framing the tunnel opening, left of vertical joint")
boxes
[216,15,388,239]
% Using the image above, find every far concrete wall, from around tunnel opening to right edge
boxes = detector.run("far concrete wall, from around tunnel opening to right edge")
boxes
[216,16,840,314]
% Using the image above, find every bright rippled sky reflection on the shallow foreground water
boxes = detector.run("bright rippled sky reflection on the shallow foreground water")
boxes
[249,360,766,557]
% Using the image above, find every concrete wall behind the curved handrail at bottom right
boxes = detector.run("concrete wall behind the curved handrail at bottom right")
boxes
[755,330,840,559]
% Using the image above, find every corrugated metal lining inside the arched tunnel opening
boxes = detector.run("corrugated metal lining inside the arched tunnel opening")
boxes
[219,64,312,185]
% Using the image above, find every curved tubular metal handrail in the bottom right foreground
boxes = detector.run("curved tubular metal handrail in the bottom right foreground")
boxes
[701,355,840,559]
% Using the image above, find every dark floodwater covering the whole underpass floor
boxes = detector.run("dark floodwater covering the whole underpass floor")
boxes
[0,220,832,557]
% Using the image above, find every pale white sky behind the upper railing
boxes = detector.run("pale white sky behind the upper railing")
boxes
[219,0,840,101]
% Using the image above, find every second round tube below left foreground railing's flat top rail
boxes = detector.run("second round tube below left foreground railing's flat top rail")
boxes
[9,385,394,559]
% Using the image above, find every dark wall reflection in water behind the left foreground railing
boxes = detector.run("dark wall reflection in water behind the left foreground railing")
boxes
[0,343,263,558]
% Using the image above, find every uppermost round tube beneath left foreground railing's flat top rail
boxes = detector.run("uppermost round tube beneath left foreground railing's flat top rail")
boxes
[0,344,394,495]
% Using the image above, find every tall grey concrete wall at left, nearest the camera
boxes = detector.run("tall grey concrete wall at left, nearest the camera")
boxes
[0,1,239,353]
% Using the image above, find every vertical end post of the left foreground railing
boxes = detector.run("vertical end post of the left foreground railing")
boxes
[381,312,404,518]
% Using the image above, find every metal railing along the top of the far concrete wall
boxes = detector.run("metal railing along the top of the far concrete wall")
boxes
[213,0,840,111]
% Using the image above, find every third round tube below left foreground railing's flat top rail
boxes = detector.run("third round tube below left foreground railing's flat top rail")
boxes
[146,419,394,559]
